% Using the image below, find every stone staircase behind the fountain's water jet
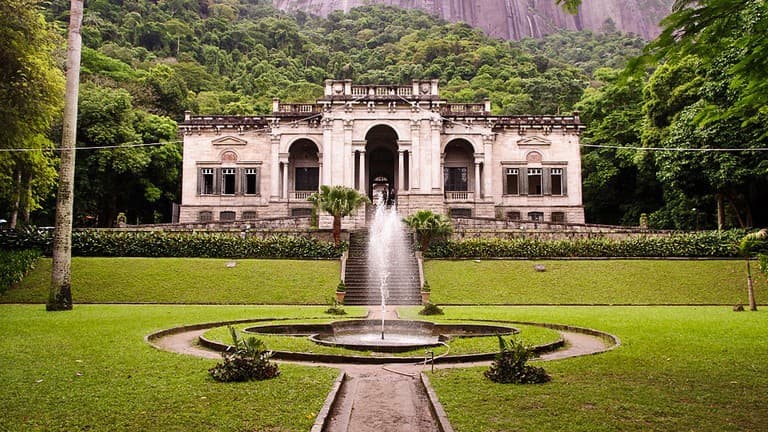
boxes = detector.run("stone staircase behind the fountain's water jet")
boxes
[344,231,421,305]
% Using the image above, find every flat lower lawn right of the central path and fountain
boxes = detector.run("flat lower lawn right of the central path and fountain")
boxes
[420,307,768,432]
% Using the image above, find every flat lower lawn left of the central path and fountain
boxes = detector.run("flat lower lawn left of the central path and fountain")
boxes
[0,305,338,431]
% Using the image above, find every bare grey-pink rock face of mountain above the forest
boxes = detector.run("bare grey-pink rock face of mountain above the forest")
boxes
[273,0,673,40]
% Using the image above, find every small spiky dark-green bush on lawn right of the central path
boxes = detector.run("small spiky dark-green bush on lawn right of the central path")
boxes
[485,336,552,384]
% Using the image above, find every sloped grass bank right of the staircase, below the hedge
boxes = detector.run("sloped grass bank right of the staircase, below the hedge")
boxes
[424,260,768,305]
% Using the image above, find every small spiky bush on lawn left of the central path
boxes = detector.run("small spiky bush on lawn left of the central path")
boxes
[208,326,280,382]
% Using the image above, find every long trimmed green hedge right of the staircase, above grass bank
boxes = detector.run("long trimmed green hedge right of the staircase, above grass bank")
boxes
[424,230,744,258]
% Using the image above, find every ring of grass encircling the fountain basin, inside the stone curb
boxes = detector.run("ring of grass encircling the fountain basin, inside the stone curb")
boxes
[205,317,559,358]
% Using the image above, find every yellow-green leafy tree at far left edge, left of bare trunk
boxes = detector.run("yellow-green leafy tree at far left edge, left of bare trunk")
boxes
[0,0,64,227]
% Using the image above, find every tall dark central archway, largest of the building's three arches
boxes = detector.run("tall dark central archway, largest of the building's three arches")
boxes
[365,125,404,199]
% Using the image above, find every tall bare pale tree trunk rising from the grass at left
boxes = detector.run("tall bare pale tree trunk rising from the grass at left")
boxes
[45,0,83,311]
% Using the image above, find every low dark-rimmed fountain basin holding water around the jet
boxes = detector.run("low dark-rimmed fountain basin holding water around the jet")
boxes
[244,320,519,352]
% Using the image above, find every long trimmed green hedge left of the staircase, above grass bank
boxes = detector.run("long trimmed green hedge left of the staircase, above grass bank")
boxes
[0,231,346,258]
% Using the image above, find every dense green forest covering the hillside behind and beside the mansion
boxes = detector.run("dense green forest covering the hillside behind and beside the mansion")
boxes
[0,0,768,229]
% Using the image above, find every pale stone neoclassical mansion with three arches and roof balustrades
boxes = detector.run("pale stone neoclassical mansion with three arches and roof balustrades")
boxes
[179,80,584,223]
